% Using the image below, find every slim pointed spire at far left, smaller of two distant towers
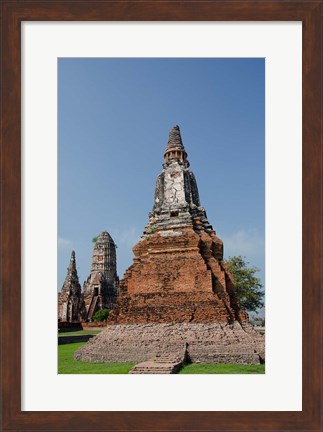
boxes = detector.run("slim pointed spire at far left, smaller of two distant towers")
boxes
[58,251,83,322]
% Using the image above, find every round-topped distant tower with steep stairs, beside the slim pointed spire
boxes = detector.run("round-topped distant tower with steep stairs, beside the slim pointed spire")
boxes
[83,231,119,321]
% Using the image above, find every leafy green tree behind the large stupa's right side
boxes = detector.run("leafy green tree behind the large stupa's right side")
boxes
[226,255,264,312]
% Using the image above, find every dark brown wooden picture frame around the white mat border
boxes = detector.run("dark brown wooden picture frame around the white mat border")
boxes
[1,0,322,431]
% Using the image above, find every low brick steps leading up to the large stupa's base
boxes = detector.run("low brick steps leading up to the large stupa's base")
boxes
[129,344,187,374]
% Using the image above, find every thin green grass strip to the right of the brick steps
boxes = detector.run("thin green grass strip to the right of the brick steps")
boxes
[179,363,265,374]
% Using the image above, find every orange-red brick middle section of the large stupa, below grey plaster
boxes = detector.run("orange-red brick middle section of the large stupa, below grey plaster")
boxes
[108,226,248,324]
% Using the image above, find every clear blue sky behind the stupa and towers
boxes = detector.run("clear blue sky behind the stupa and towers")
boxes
[58,58,265,300]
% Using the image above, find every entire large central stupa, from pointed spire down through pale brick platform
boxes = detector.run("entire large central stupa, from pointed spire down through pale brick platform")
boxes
[75,126,264,364]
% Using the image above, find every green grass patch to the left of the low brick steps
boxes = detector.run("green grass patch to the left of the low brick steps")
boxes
[58,342,136,374]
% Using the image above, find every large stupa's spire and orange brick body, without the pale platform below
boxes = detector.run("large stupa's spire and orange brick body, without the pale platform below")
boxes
[109,126,248,324]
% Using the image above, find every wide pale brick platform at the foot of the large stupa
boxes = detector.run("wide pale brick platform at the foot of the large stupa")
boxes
[75,322,264,364]
